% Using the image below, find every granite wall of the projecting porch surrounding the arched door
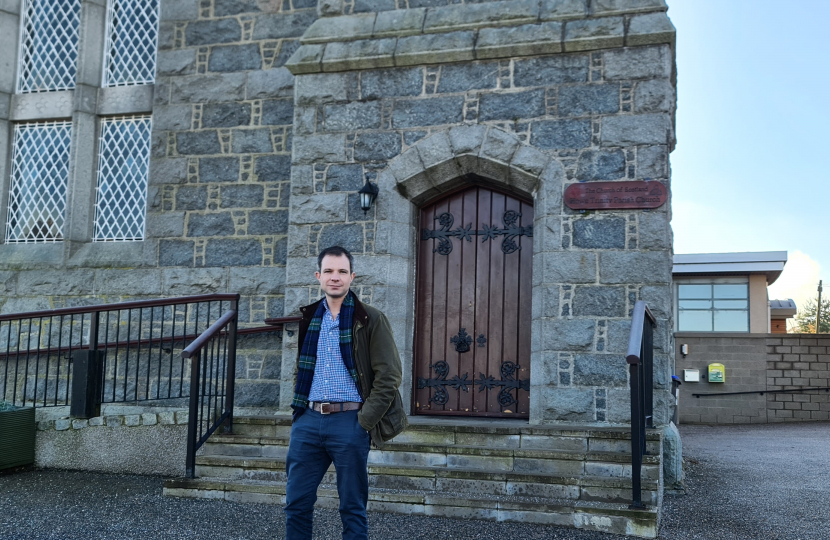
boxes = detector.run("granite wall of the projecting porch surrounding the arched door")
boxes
[282,2,675,424]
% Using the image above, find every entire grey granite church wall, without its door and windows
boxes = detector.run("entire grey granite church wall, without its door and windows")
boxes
[0,0,675,423]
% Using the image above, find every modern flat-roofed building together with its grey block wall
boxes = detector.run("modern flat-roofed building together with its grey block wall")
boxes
[673,251,830,424]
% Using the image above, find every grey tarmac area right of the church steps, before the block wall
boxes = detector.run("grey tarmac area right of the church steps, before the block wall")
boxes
[660,422,830,540]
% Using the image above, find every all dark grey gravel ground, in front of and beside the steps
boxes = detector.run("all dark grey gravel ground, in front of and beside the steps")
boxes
[0,423,830,540]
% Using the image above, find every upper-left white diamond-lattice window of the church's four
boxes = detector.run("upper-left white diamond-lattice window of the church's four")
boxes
[17,0,81,93]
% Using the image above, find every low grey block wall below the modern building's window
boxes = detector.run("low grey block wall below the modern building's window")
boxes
[675,333,830,424]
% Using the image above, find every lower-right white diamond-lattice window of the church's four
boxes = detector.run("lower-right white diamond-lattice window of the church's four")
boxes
[92,116,151,242]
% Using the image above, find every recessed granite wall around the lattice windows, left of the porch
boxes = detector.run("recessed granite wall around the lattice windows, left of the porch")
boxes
[0,0,324,412]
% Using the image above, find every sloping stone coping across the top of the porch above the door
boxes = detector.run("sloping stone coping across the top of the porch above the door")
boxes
[286,0,675,75]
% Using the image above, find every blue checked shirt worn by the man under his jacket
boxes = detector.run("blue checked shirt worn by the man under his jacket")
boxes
[308,299,363,403]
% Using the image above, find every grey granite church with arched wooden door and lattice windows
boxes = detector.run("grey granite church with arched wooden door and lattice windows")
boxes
[0,0,676,532]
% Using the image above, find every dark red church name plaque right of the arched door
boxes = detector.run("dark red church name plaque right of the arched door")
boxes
[565,180,669,210]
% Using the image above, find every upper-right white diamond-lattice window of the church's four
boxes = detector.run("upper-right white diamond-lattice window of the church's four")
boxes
[104,0,159,86]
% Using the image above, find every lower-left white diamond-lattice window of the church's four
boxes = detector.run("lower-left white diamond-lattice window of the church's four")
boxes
[6,122,72,243]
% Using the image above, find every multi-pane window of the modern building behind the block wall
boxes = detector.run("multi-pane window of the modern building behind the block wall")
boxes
[676,278,749,332]
